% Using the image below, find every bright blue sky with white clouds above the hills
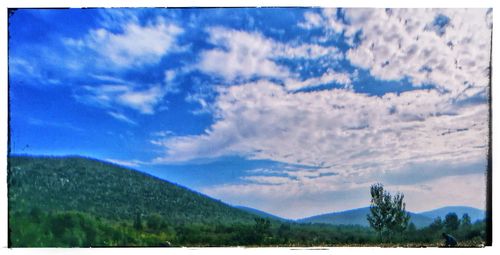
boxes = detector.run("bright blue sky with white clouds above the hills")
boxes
[8,8,492,219]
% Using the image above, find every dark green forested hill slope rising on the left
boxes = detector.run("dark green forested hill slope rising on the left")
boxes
[8,156,262,223]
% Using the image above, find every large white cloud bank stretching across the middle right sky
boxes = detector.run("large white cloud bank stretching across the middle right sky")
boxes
[153,81,488,172]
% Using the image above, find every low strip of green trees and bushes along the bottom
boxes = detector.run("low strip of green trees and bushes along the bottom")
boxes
[9,208,485,247]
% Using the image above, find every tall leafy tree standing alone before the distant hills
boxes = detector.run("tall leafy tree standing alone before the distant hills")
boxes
[367,183,410,240]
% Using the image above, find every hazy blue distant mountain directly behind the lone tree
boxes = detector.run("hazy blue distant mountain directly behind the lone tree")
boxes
[297,207,433,228]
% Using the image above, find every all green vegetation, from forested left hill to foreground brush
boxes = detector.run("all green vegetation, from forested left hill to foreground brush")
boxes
[8,157,485,247]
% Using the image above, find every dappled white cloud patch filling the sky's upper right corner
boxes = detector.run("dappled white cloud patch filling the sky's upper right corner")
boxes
[320,8,491,96]
